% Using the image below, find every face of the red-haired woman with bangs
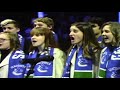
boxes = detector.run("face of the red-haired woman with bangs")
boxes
[31,34,45,47]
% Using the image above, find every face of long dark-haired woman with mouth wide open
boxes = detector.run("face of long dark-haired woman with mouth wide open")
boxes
[69,26,83,44]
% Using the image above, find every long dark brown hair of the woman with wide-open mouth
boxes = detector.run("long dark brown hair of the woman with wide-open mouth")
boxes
[68,22,101,58]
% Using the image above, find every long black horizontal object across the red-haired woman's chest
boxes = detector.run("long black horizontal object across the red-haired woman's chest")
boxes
[20,55,54,64]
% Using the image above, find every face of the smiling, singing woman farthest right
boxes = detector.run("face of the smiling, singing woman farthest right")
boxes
[102,25,115,44]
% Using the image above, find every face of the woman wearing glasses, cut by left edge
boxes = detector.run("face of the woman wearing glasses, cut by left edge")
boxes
[0,33,10,50]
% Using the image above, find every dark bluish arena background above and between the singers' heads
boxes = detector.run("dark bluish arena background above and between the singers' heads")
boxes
[0,12,118,50]
